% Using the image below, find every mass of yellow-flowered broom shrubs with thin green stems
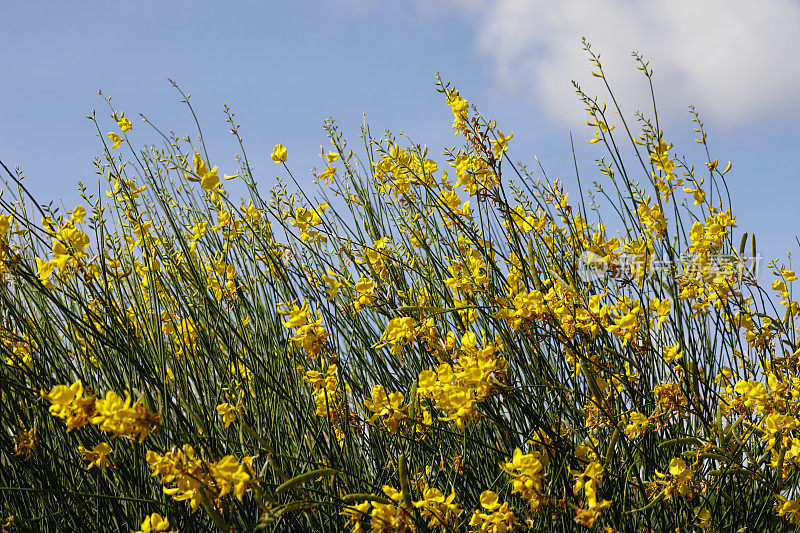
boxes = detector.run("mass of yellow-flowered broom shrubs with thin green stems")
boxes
[0,46,800,532]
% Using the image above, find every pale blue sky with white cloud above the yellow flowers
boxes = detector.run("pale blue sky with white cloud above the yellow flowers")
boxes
[0,0,800,266]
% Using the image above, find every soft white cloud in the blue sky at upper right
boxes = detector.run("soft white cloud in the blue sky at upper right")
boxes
[449,0,800,125]
